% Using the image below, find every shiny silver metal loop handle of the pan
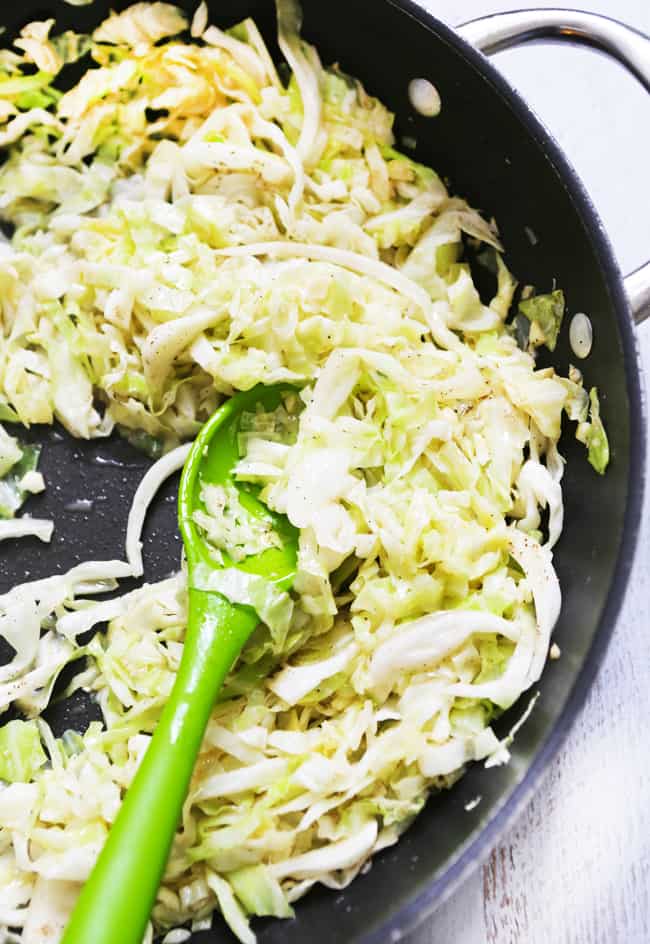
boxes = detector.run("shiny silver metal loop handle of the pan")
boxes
[456,9,650,324]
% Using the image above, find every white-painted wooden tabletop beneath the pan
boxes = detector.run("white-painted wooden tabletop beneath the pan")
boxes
[409,0,650,944]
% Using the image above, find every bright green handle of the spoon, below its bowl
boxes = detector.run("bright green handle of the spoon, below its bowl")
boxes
[63,590,258,944]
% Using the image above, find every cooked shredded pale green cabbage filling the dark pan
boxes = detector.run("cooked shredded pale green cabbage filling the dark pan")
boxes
[0,0,609,942]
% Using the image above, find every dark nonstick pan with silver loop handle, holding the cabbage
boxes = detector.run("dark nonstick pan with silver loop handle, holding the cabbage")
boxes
[0,0,650,944]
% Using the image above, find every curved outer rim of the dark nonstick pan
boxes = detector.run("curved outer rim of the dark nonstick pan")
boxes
[357,0,648,944]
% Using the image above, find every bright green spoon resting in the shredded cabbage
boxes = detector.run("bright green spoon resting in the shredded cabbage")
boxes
[63,386,297,944]
